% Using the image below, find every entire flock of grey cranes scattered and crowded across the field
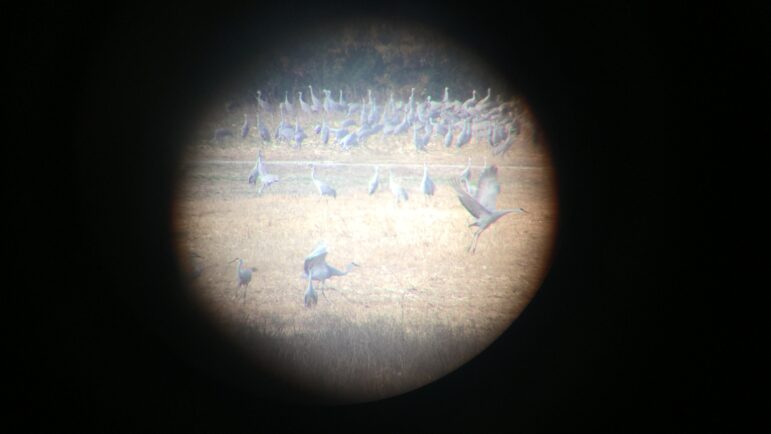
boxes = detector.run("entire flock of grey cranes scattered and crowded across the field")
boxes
[214,86,525,307]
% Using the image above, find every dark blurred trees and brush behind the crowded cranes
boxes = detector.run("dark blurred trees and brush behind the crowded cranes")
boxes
[240,22,511,103]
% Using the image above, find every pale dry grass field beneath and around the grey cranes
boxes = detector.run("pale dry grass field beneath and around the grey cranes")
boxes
[175,108,557,402]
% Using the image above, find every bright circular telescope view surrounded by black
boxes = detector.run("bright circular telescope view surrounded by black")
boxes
[174,20,558,403]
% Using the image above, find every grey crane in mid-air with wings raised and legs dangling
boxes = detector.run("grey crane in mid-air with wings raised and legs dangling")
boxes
[453,165,525,253]
